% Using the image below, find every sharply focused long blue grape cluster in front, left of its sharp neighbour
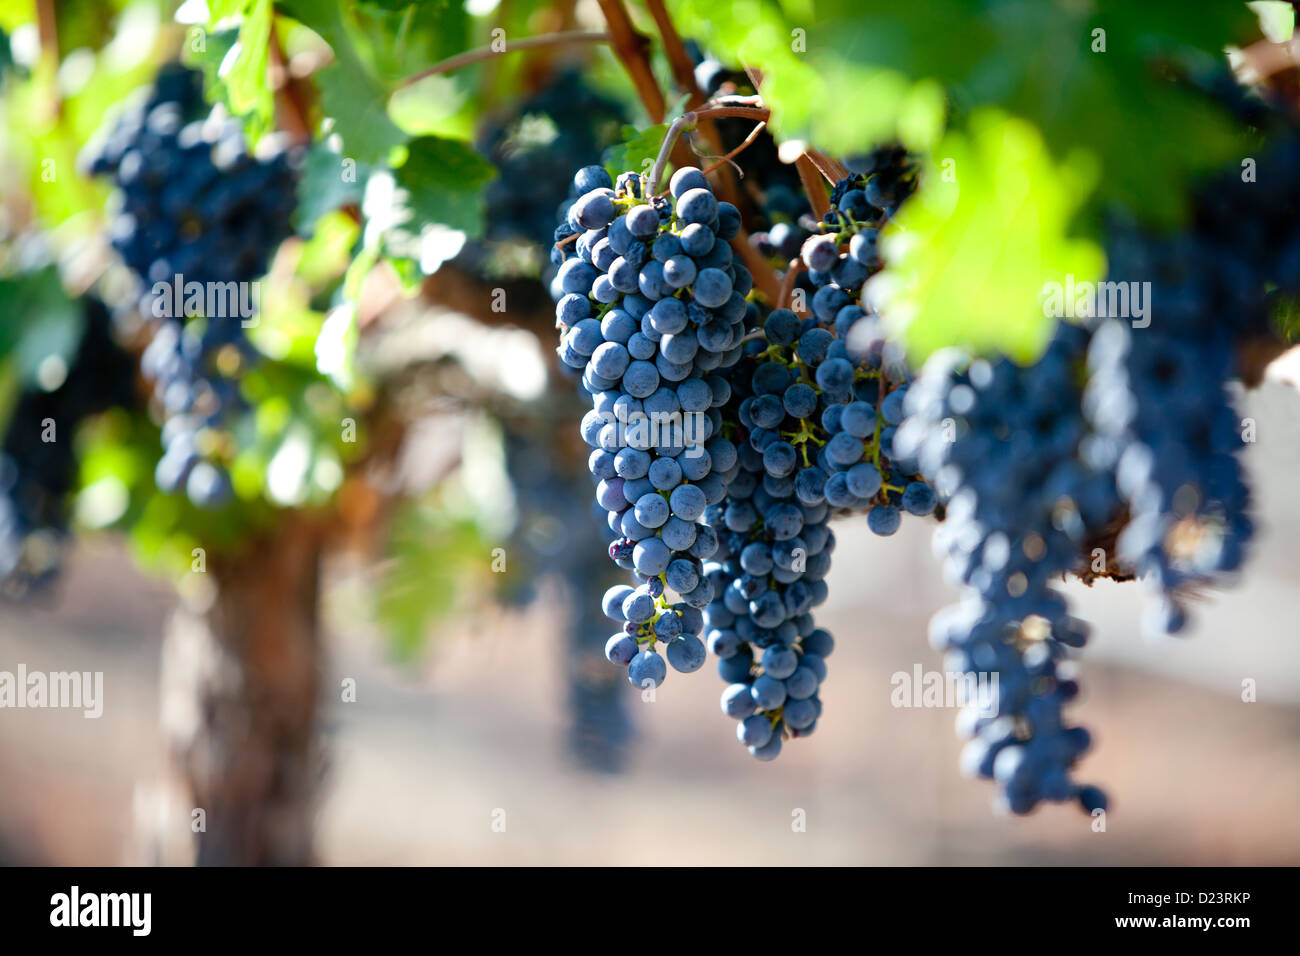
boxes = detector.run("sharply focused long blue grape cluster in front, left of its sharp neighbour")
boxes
[551,166,757,687]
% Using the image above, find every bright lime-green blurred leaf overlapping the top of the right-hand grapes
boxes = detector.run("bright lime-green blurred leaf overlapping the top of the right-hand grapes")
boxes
[868,111,1105,362]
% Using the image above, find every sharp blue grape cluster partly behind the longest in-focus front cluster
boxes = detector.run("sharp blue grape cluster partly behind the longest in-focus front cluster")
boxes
[705,177,937,760]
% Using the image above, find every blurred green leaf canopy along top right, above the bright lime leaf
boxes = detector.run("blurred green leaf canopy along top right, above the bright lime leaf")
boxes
[672,0,1258,221]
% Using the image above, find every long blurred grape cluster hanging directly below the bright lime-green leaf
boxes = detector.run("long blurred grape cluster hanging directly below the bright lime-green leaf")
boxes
[894,323,1119,813]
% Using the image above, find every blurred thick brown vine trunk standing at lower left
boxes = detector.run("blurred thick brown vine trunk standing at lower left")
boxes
[155,515,322,866]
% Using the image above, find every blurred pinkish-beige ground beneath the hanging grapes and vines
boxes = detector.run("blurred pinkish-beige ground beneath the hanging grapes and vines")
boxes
[0,389,1300,865]
